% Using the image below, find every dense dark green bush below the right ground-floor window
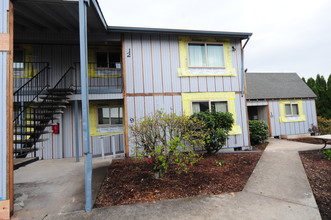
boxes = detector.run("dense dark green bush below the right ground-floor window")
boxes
[191,111,234,154]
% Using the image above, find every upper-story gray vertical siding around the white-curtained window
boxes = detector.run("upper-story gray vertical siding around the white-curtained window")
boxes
[124,34,241,93]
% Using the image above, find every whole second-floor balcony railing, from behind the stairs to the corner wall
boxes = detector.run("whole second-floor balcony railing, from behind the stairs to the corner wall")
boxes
[14,62,123,94]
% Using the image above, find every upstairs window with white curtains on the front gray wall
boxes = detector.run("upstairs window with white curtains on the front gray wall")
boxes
[188,43,224,67]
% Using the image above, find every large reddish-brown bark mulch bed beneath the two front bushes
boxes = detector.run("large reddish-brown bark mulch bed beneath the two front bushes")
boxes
[95,152,262,207]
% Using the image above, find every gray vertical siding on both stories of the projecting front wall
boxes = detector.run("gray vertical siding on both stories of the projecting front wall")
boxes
[123,33,249,153]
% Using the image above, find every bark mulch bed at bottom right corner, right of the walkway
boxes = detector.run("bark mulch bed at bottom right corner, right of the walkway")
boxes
[299,150,331,220]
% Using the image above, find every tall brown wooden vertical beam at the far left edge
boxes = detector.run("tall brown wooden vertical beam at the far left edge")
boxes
[6,2,14,214]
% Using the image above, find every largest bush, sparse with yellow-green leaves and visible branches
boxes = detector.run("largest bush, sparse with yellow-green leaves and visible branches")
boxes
[130,111,206,178]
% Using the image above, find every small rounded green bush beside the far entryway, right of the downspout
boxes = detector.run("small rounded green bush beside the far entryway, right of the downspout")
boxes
[249,120,269,146]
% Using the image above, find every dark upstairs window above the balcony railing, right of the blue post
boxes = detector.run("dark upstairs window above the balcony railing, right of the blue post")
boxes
[96,52,121,69]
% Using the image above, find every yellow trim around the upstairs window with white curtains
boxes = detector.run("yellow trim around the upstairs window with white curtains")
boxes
[178,37,236,77]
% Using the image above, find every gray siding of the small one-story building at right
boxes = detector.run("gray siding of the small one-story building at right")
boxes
[247,99,317,136]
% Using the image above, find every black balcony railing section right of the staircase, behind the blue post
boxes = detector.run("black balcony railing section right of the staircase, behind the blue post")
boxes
[73,63,123,93]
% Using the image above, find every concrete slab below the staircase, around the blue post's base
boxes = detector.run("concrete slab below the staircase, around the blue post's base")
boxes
[12,158,111,219]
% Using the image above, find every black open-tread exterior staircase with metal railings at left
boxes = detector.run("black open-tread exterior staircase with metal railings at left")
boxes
[14,67,74,169]
